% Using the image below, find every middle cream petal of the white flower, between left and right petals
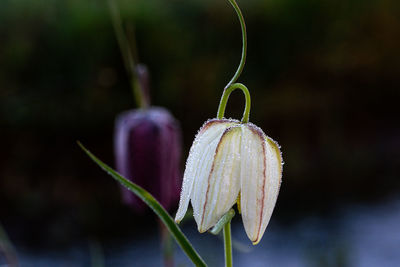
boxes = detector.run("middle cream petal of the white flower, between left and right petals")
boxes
[198,126,241,232]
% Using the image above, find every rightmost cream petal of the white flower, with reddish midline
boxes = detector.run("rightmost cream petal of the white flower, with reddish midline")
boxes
[241,123,282,245]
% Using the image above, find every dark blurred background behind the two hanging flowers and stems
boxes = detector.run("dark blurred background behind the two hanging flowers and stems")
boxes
[0,0,400,266]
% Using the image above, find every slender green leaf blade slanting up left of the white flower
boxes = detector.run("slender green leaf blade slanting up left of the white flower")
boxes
[78,142,207,267]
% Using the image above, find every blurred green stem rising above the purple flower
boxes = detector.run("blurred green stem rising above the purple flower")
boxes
[108,0,149,108]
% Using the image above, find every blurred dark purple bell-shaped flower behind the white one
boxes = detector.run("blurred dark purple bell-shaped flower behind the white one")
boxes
[114,107,181,212]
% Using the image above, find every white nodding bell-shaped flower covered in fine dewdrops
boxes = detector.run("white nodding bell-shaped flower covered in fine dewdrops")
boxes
[175,119,282,244]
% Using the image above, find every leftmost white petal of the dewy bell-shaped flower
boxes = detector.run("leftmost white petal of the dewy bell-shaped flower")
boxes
[175,120,238,222]
